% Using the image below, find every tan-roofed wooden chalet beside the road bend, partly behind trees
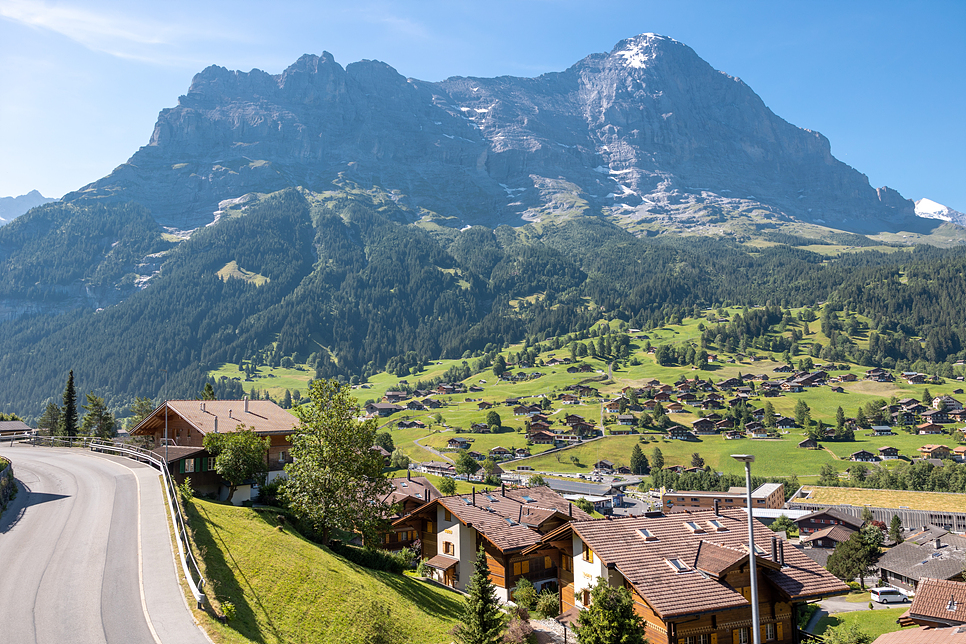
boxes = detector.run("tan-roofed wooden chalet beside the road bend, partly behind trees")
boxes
[131,398,300,504]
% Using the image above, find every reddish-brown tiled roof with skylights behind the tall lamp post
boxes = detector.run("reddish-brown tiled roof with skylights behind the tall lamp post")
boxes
[544,510,848,619]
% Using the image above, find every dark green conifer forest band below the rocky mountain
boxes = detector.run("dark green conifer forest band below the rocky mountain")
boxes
[0,190,966,415]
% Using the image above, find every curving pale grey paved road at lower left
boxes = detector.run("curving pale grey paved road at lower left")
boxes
[0,445,209,644]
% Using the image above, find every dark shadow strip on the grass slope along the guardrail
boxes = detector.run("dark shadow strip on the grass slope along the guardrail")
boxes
[185,503,284,642]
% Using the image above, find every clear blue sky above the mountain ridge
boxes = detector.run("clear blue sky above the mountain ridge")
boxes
[0,0,966,211]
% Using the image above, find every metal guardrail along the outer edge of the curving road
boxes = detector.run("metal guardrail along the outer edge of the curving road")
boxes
[29,436,206,610]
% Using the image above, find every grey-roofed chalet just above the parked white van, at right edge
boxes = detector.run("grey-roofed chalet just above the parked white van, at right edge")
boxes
[878,526,966,600]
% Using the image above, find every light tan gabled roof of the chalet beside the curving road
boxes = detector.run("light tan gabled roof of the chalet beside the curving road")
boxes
[131,400,299,436]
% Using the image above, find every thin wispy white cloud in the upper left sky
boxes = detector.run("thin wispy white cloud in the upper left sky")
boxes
[0,0,242,65]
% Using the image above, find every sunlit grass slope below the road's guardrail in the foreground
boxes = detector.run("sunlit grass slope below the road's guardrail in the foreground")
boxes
[189,499,459,644]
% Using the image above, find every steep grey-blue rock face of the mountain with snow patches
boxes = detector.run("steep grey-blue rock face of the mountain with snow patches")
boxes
[65,34,922,232]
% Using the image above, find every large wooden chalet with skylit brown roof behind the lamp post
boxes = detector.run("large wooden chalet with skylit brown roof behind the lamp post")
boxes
[526,510,848,644]
